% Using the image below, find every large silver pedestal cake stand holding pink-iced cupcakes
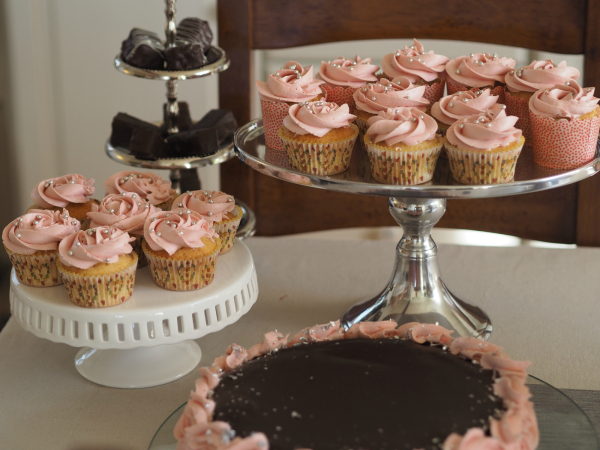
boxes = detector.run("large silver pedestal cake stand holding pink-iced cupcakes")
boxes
[235,119,600,339]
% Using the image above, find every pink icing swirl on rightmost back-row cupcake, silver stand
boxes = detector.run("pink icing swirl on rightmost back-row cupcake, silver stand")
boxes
[505,59,579,92]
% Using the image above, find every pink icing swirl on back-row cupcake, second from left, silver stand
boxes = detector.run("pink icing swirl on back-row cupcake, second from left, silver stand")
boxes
[317,55,379,88]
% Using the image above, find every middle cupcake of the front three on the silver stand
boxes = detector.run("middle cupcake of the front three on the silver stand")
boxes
[364,108,444,185]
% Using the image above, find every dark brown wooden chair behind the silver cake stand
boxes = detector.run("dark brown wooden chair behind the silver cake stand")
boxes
[218,0,600,246]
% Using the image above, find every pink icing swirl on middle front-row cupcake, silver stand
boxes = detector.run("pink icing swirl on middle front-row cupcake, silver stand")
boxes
[366,108,438,145]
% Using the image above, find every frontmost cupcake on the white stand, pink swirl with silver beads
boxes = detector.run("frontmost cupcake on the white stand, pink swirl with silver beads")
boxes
[56,227,138,308]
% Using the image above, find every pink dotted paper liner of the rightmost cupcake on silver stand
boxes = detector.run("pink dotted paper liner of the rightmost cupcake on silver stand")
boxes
[529,111,600,169]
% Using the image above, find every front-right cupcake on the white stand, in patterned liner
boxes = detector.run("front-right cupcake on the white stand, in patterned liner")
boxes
[142,211,221,291]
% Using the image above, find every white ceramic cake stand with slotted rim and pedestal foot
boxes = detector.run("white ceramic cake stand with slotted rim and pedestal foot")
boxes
[10,240,258,388]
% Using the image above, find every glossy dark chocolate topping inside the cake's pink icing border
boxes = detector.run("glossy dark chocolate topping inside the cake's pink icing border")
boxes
[213,339,504,450]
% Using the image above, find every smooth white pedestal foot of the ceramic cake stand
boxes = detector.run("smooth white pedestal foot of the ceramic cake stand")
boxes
[75,341,202,389]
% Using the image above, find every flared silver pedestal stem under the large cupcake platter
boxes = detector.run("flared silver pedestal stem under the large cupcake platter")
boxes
[342,197,492,339]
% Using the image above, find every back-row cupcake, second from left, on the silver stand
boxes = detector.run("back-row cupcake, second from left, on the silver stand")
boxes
[316,55,379,111]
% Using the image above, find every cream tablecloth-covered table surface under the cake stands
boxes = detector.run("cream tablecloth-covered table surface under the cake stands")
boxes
[0,235,600,450]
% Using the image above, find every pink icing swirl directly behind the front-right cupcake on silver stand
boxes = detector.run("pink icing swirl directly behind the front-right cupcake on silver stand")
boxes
[431,89,506,125]
